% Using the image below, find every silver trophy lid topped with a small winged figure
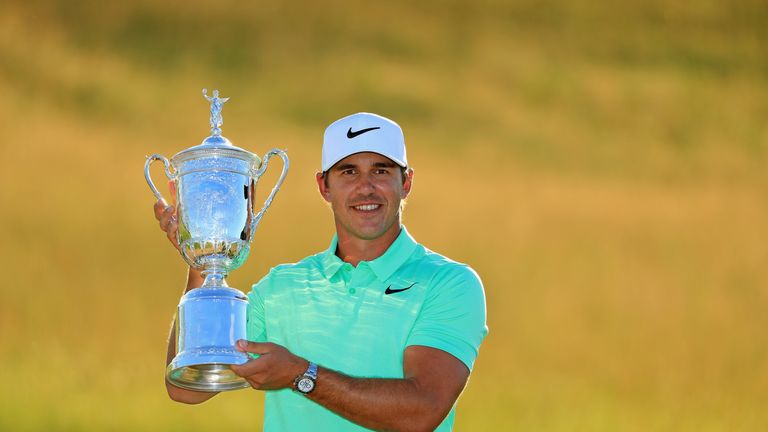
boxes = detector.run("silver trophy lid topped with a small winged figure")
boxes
[171,89,261,167]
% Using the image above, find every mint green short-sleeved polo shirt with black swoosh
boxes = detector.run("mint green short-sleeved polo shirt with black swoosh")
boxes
[247,227,488,431]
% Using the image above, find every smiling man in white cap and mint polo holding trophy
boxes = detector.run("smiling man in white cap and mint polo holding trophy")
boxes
[155,113,487,431]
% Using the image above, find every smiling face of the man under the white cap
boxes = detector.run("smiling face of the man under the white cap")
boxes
[317,152,413,240]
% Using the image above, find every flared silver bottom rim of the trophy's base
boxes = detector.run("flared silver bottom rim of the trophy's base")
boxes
[166,353,250,392]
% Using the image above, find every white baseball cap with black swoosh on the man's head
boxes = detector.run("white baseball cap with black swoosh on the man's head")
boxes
[322,113,408,172]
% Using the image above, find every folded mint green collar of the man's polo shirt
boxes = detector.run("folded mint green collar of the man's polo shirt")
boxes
[322,226,418,281]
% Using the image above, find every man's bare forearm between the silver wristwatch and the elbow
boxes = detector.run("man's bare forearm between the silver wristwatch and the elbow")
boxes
[307,367,451,431]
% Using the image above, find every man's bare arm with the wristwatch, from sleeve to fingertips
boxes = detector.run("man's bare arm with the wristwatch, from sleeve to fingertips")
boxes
[232,341,469,431]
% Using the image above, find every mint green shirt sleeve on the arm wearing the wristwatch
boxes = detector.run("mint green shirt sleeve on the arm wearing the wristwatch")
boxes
[406,265,488,370]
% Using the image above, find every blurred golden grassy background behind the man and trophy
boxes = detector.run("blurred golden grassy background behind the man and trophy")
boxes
[0,0,768,431]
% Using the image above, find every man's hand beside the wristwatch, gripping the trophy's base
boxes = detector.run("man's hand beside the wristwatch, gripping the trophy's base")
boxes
[231,339,309,390]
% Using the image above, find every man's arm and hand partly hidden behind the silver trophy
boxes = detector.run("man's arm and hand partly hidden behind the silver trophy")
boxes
[154,201,218,404]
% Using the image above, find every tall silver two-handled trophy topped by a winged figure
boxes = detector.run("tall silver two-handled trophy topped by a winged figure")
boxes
[144,89,288,392]
